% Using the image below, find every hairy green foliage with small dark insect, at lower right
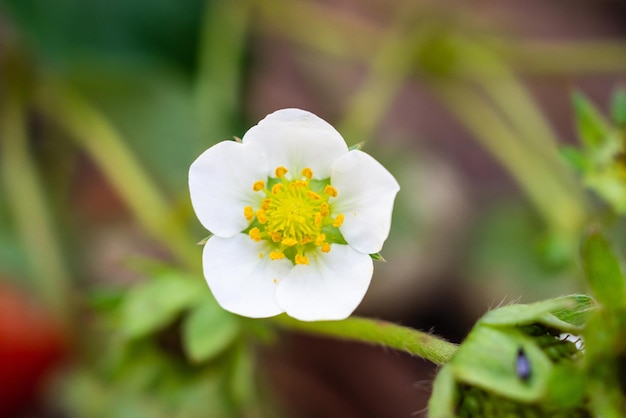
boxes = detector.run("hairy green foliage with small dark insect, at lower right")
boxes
[429,295,594,418]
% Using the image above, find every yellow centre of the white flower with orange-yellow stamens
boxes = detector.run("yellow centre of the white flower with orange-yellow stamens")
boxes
[243,166,344,264]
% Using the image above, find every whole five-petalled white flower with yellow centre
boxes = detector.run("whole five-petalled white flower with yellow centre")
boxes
[189,109,400,321]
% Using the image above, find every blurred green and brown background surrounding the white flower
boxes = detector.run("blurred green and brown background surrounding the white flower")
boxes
[0,0,626,418]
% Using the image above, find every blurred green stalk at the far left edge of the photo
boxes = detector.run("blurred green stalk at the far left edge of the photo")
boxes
[0,95,71,322]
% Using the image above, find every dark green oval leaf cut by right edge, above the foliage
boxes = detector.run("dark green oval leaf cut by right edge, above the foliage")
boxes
[582,232,626,308]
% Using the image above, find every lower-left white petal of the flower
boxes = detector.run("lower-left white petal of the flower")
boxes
[202,234,292,318]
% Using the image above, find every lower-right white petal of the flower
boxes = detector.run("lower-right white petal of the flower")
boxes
[276,244,374,321]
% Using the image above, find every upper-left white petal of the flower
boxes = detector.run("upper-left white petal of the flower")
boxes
[189,141,269,237]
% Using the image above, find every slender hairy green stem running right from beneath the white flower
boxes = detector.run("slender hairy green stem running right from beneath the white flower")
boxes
[273,315,458,366]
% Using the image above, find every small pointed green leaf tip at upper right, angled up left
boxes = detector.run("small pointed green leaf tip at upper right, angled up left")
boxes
[572,92,612,149]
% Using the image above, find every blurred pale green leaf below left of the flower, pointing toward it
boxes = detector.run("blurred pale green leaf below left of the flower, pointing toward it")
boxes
[121,273,209,338]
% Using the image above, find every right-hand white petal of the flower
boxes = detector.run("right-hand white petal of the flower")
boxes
[330,150,400,254]
